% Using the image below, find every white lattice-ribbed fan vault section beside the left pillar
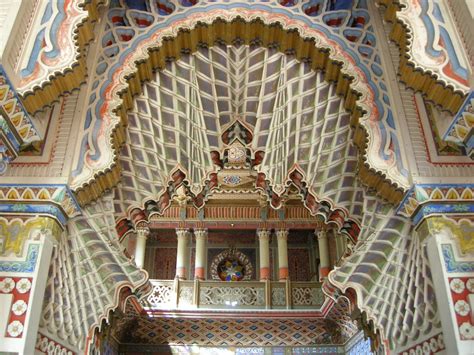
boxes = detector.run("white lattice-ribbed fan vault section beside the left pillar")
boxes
[40,195,146,349]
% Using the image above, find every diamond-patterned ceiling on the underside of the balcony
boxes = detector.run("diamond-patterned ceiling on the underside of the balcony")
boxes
[111,299,359,346]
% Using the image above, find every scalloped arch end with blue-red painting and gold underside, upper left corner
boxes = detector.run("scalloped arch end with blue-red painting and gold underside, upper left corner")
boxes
[14,0,105,113]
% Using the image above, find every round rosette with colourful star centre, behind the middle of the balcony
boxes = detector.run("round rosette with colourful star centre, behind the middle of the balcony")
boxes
[211,249,253,281]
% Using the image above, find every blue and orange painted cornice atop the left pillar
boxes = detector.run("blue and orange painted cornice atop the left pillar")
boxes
[0,184,82,227]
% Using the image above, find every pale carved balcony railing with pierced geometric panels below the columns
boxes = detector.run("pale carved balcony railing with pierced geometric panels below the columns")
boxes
[146,280,325,311]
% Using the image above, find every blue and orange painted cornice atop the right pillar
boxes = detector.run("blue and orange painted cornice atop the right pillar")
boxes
[397,184,474,225]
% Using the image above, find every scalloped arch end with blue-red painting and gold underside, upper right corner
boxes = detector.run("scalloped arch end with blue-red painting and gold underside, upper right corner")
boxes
[378,0,470,114]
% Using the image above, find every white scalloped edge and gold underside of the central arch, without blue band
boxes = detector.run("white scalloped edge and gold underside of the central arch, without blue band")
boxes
[72,8,408,205]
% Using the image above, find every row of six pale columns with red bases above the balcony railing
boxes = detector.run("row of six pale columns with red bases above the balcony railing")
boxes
[135,228,331,281]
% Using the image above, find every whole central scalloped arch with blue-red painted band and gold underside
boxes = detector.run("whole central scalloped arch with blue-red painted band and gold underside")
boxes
[73,5,408,204]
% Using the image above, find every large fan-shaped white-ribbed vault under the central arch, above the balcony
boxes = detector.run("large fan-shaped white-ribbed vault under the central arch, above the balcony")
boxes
[116,45,362,222]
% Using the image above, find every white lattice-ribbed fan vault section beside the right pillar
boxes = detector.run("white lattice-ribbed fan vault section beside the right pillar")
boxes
[329,197,440,348]
